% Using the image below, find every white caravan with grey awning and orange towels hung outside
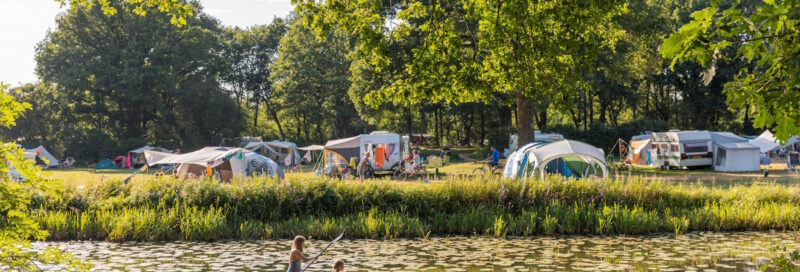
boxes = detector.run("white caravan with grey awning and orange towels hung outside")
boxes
[323,132,408,174]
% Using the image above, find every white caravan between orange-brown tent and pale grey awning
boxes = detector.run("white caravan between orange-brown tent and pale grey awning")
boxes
[650,130,713,169]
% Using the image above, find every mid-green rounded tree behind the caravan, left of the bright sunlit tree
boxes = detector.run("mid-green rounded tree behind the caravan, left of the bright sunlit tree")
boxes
[270,20,365,142]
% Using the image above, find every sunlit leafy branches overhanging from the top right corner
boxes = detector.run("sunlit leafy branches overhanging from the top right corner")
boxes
[661,0,800,141]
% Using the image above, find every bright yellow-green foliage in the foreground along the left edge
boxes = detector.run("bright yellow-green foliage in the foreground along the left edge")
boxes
[0,82,90,271]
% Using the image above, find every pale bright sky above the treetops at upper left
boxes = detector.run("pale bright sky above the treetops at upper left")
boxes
[0,0,292,87]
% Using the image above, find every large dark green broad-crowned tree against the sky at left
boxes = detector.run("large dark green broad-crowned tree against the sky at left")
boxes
[36,2,242,159]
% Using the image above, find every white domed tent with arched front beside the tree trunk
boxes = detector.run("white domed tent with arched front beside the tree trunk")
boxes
[503,140,608,178]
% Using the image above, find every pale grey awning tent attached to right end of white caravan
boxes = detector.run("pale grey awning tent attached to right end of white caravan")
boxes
[710,132,761,172]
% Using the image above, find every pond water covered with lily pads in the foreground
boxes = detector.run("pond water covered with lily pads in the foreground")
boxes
[34,232,800,271]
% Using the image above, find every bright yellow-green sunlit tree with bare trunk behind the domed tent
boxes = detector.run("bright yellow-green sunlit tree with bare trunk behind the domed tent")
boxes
[294,0,624,147]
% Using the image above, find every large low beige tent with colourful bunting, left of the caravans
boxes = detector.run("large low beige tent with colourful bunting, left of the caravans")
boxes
[144,147,284,181]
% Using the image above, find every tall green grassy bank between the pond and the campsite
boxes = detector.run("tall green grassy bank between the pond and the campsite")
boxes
[31,178,800,241]
